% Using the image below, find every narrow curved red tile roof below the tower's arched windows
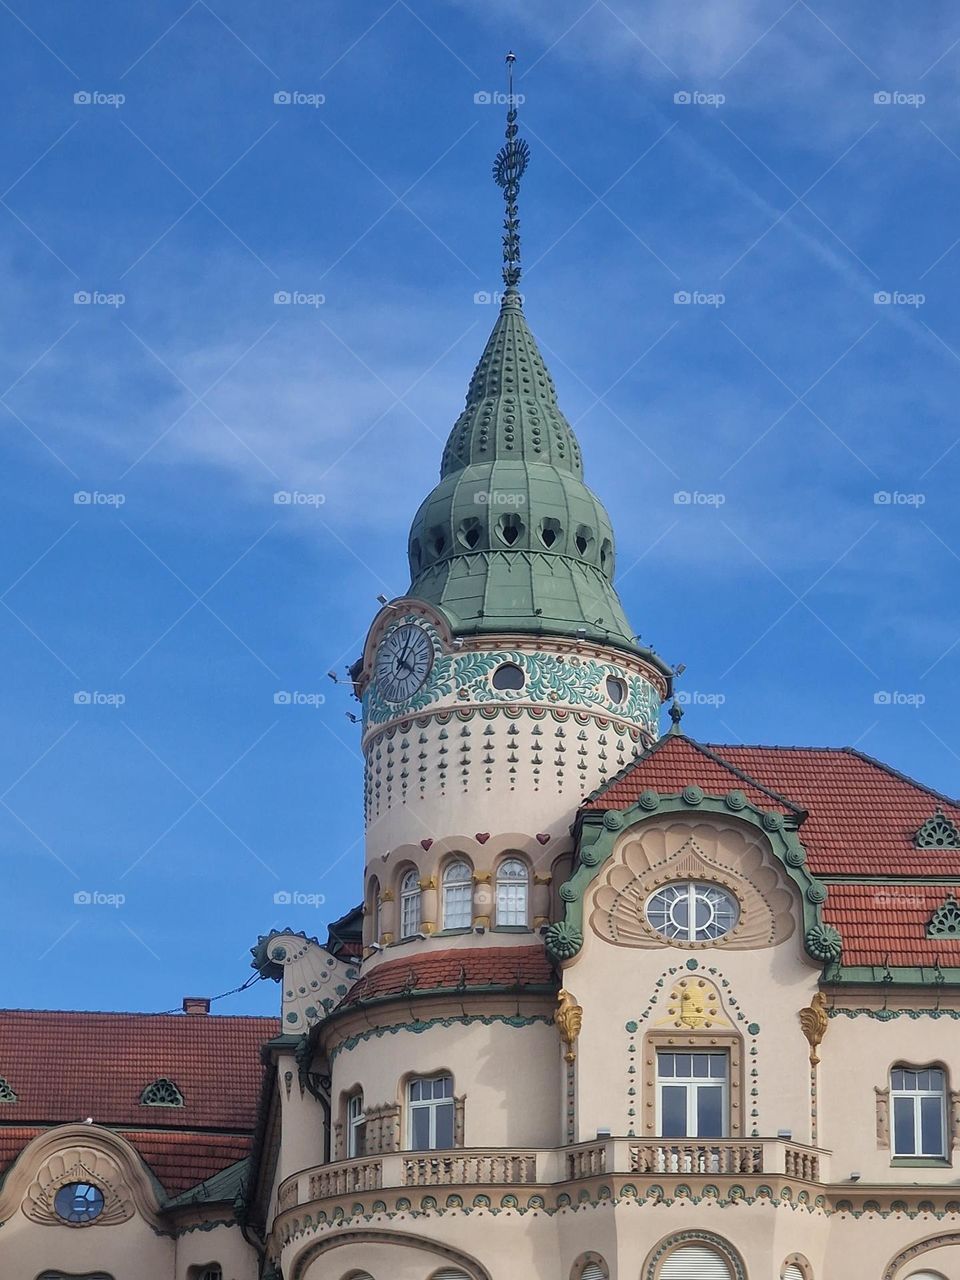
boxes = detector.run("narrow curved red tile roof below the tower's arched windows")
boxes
[340,940,556,1007]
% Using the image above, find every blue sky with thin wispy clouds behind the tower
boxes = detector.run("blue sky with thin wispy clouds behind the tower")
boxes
[0,0,960,1012]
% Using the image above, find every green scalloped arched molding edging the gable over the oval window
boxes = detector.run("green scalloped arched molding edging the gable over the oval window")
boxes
[547,783,840,963]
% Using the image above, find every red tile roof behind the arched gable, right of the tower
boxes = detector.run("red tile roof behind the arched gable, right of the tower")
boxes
[585,735,960,968]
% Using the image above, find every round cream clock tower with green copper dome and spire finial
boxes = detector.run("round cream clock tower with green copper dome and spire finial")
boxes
[352,72,672,963]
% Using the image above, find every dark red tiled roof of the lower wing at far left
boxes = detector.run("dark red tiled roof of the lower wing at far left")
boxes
[0,1009,280,1193]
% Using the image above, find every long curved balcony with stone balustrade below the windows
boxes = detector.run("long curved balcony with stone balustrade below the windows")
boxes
[278,1138,829,1212]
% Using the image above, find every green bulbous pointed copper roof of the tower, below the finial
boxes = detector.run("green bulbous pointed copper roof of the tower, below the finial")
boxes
[407,288,667,671]
